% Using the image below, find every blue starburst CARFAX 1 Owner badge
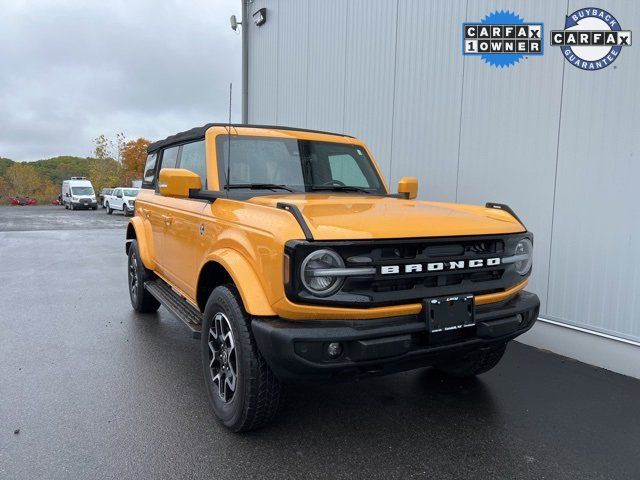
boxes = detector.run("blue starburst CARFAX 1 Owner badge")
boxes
[462,10,544,68]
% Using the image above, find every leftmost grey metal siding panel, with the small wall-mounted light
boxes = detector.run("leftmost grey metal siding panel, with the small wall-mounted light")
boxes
[246,0,279,124]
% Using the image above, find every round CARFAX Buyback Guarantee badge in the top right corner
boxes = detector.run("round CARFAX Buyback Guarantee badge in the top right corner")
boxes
[551,7,631,70]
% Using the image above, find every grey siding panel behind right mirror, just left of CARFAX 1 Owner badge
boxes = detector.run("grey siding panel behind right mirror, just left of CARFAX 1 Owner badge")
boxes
[387,0,466,201]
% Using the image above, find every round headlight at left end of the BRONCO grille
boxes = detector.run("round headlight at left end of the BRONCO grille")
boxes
[300,249,344,297]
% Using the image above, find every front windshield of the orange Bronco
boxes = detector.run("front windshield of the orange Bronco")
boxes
[217,135,386,195]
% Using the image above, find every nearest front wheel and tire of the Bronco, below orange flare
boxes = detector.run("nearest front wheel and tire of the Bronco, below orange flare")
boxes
[201,285,282,432]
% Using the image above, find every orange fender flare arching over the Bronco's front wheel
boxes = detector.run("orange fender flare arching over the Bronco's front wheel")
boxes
[203,248,276,316]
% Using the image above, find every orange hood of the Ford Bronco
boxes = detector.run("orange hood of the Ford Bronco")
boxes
[249,194,525,240]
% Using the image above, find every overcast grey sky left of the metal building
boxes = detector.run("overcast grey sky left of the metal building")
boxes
[0,0,241,160]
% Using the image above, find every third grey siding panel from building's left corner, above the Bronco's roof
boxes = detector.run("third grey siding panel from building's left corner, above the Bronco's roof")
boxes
[306,0,347,132]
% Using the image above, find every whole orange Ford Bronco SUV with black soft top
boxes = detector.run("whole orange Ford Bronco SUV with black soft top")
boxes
[126,124,540,431]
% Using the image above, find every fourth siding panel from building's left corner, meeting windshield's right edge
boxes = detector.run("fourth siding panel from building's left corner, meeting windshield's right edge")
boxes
[342,0,397,175]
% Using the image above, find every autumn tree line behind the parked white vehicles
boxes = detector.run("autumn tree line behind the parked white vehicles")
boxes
[0,133,151,204]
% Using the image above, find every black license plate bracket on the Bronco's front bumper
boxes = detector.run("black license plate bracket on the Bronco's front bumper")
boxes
[425,295,476,334]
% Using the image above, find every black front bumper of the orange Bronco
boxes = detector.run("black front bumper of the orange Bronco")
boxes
[251,292,540,382]
